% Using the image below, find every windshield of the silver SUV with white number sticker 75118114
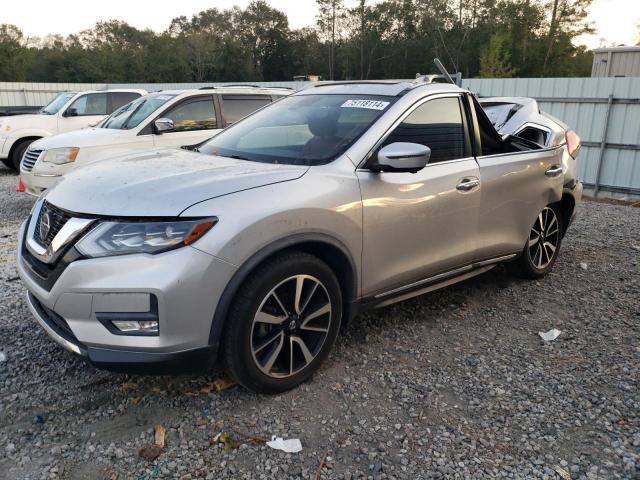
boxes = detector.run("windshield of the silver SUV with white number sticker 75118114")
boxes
[198,95,395,165]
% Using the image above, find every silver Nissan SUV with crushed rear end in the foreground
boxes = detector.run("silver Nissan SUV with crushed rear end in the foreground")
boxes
[18,79,582,392]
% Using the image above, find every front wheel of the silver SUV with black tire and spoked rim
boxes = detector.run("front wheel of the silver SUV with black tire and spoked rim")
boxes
[223,251,342,393]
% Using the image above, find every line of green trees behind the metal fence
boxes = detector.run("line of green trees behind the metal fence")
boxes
[0,0,593,83]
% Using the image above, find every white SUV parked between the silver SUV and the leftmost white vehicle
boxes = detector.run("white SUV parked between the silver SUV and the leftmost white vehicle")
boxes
[20,86,293,195]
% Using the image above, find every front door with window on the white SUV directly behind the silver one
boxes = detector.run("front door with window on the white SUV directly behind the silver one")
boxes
[153,95,221,147]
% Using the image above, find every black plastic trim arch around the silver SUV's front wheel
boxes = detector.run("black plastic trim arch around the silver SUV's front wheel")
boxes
[209,233,358,352]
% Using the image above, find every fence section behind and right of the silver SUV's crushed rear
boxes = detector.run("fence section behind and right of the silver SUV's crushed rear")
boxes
[462,77,640,196]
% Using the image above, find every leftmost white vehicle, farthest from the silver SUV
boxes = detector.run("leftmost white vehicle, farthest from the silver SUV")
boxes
[0,89,147,170]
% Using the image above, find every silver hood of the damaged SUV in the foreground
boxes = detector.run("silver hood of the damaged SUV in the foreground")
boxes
[47,149,309,217]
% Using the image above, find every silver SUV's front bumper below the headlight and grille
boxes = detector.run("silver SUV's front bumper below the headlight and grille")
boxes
[17,218,235,373]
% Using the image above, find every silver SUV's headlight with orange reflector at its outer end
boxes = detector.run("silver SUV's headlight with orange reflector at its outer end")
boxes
[76,218,218,258]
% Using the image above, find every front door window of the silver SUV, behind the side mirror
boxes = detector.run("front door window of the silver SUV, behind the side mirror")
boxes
[384,97,470,163]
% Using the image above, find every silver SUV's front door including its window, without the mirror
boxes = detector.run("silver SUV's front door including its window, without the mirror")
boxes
[357,95,481,296]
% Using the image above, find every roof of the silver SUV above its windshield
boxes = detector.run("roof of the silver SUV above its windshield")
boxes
[296,78,465,97]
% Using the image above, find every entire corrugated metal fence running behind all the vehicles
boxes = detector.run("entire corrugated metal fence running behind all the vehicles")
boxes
[0,78,640,198]
